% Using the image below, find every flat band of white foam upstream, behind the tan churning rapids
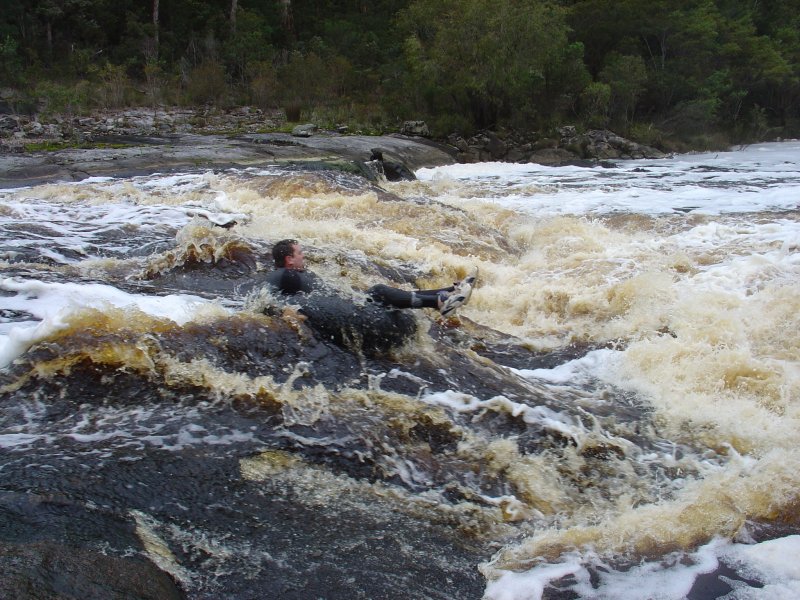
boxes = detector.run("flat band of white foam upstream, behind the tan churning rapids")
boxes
[416,142,800,216]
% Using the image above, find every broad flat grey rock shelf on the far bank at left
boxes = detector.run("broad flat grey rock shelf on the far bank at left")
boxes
[0,109,456,187]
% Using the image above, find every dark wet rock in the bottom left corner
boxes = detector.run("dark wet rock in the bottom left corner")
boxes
[0,492,185,600]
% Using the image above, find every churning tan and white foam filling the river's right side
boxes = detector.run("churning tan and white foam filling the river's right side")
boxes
[410,142,800,600]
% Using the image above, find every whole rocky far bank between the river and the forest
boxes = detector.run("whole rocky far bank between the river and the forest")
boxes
[0,107,664,187]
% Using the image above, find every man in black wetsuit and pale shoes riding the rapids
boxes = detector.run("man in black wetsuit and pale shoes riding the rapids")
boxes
[267,239,477,316]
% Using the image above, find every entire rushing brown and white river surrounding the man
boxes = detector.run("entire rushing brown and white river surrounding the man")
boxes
[0,142,800,600]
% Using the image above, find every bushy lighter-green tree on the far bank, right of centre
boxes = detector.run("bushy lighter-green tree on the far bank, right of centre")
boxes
[400,0,570,128]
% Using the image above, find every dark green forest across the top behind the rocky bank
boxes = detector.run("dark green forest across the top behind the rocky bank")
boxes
[0,0,800,149]
